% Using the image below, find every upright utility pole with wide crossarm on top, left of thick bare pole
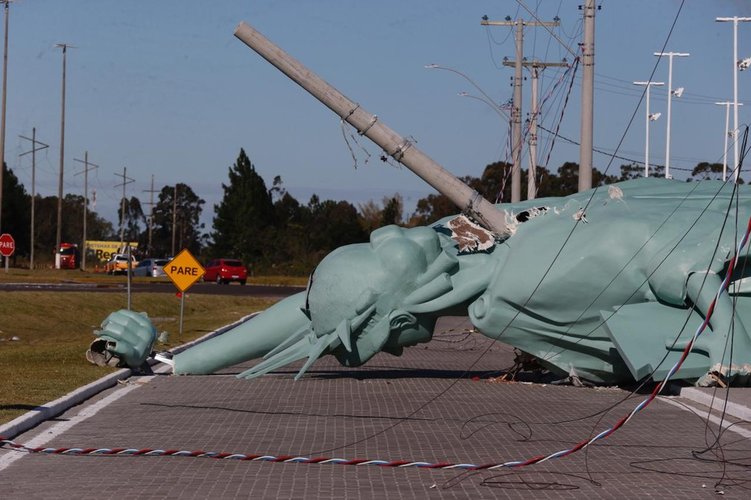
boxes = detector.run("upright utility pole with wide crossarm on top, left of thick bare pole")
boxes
[480,17,560,203]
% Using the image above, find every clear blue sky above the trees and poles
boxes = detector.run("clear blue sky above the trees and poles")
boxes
[5,0,751,230]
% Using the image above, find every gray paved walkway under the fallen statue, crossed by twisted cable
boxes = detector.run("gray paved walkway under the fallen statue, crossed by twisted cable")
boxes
[0,318,751,499]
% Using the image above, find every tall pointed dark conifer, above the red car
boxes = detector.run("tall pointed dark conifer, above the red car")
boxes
[211,149,276,264]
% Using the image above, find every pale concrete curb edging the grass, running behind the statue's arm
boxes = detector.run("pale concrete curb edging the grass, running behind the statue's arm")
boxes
[0,312,258,439]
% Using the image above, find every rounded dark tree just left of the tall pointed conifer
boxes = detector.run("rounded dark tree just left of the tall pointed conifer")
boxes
[151,183,206,257]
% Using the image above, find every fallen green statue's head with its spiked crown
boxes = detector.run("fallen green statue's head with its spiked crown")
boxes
[238,226,494,378]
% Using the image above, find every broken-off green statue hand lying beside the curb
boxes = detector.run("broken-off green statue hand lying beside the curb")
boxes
[86,309,156,369]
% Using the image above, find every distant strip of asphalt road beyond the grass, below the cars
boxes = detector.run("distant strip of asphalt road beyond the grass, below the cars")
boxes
[0,282,305,297]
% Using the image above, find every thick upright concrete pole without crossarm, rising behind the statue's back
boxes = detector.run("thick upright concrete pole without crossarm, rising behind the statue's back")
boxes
[579,0,597,192]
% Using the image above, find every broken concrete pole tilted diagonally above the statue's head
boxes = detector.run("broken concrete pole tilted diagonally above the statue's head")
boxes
[235,23,508,235]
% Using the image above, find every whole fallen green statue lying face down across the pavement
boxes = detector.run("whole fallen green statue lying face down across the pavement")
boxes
[86,179,751,385]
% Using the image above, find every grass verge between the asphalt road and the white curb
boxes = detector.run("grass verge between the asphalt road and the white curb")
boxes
[0,292,274,423]
